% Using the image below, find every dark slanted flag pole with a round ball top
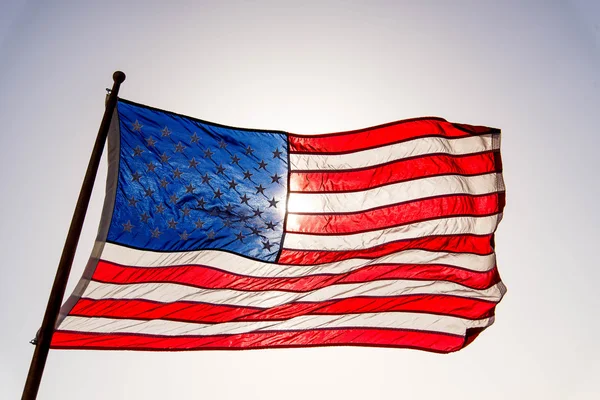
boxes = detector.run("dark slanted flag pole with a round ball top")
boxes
[21,71,125,400]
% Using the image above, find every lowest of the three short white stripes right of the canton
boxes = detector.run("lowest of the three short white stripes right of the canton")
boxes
[283,214,499,251]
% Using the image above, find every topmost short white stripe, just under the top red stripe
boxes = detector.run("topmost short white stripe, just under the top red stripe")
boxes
[290,134,500,171]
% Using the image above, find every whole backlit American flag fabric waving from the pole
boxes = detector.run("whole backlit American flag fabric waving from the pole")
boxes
[52,99,506,352]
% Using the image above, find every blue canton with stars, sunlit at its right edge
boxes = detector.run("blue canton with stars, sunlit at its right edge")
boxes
[108,101,288,262]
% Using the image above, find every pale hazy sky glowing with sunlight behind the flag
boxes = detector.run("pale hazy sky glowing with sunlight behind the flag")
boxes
[0,0,600,400]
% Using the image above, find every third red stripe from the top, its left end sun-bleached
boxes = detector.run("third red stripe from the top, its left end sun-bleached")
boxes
[286,193,504,235]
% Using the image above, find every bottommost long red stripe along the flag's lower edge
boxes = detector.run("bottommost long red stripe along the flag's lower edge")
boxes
[51,328,465,353]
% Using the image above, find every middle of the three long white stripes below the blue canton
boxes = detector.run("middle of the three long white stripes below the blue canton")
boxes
[77,280,504,308]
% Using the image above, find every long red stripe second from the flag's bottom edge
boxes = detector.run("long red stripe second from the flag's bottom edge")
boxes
[69,295,496,324]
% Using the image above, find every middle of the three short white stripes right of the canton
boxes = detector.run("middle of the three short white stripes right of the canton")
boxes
[288,173,504,214]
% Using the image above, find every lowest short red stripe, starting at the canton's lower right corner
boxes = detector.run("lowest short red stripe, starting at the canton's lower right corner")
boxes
[279,234,493,265]
